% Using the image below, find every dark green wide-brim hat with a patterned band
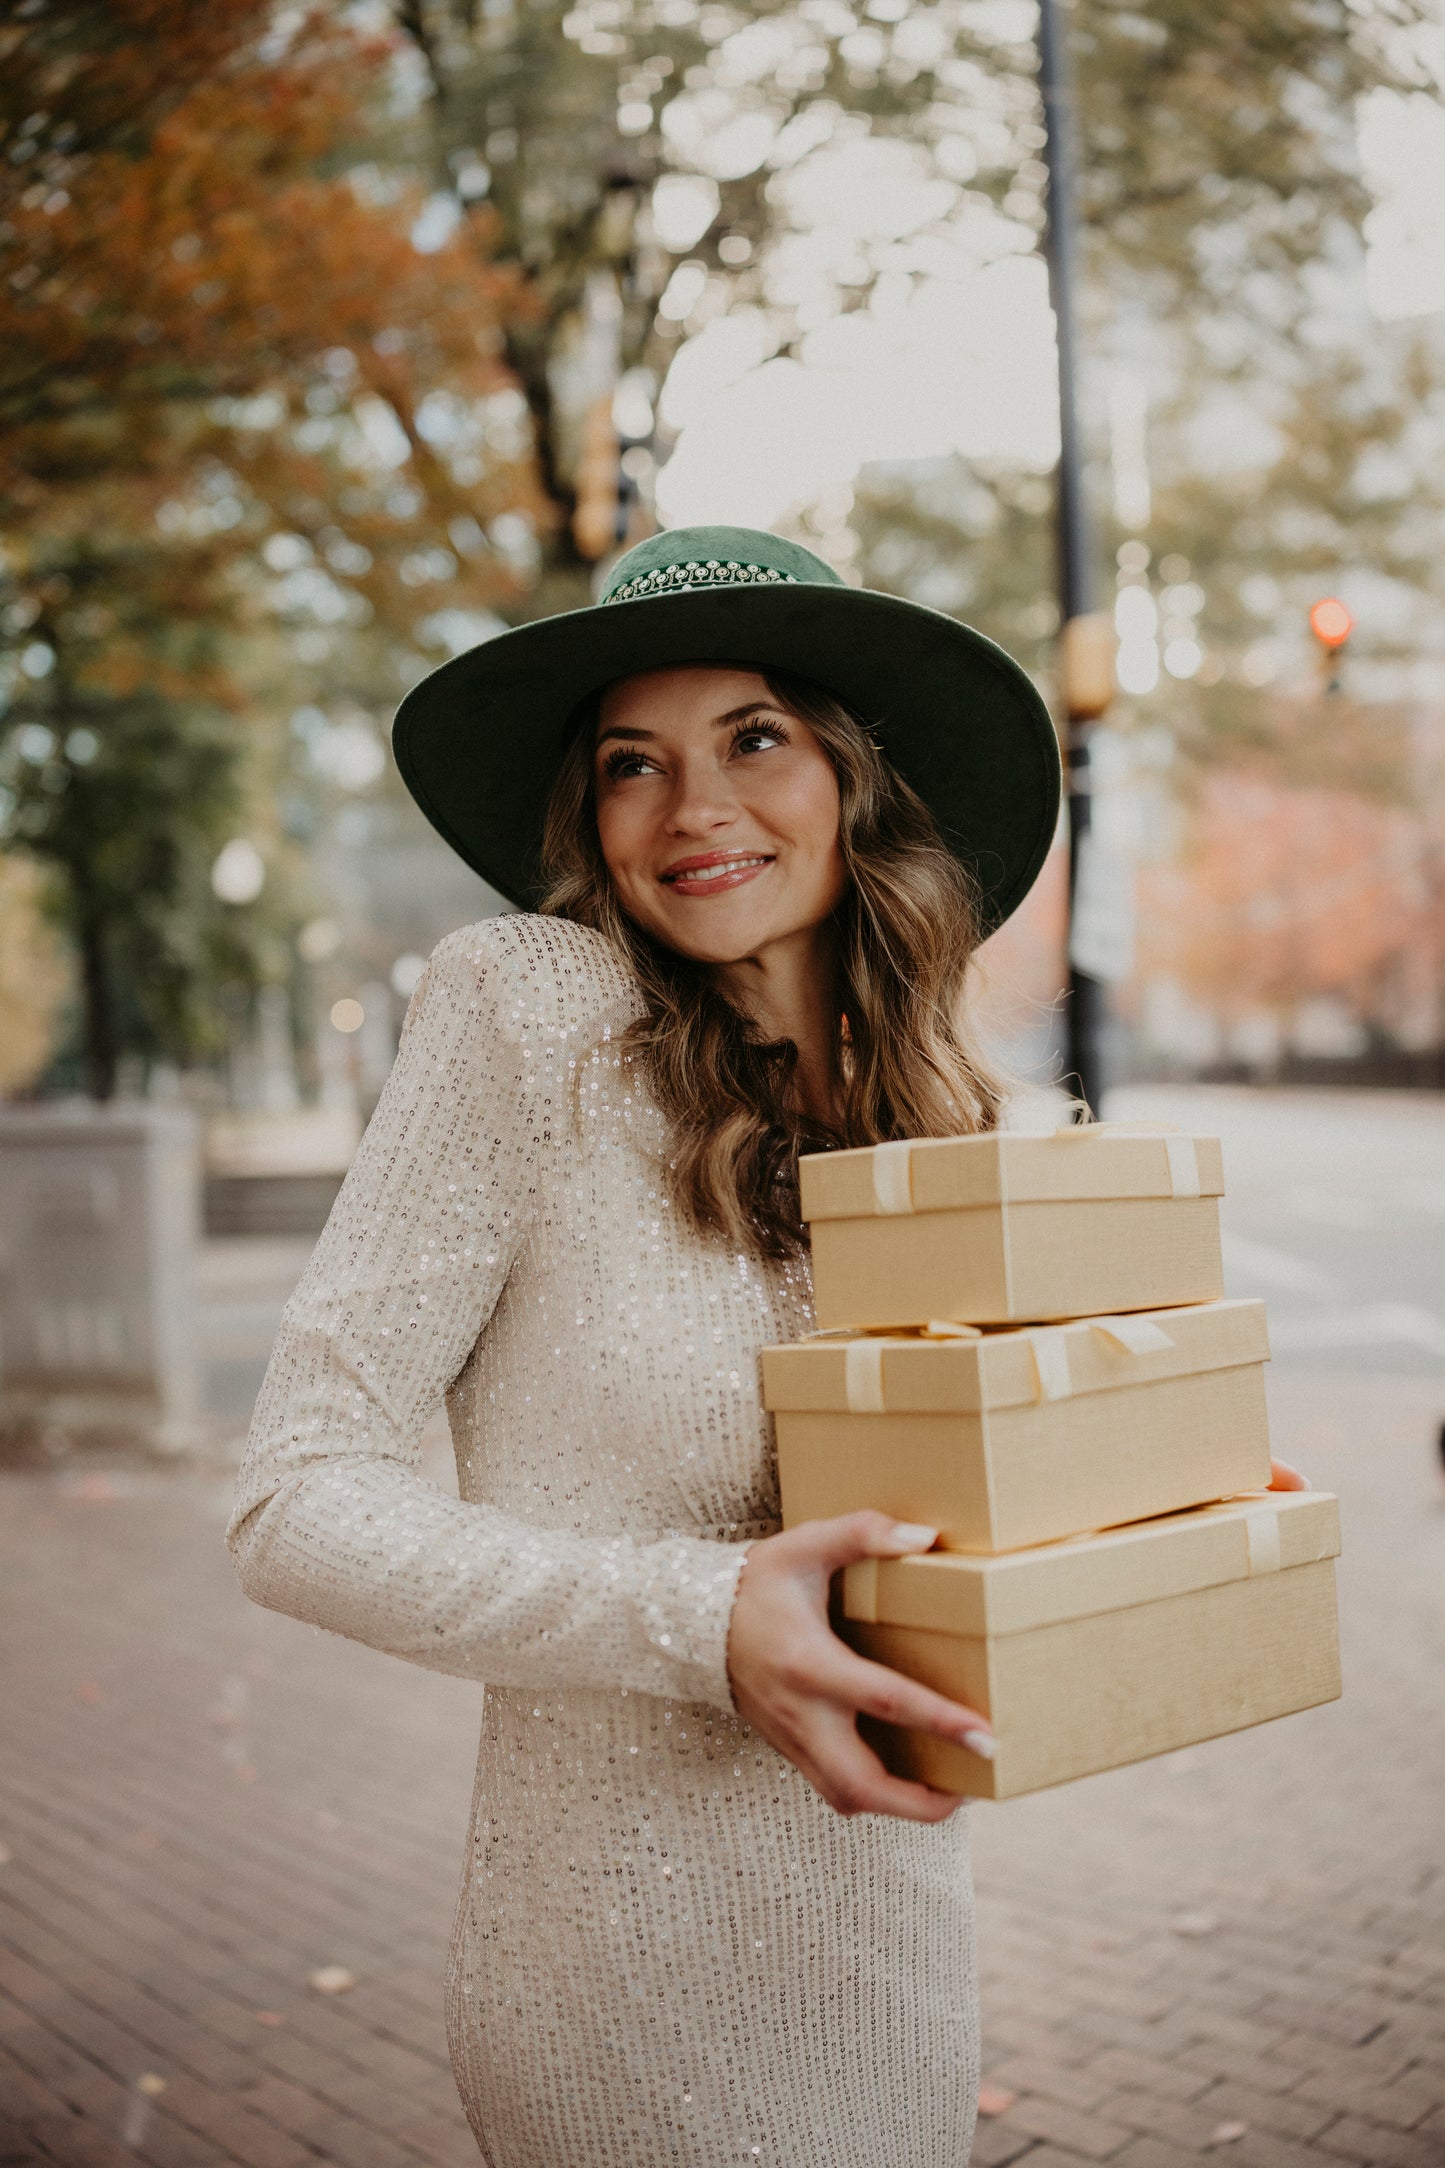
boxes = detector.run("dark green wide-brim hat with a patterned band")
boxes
[392,527,1059,928]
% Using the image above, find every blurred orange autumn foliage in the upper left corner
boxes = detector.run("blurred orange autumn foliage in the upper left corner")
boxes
[0,0,545,637]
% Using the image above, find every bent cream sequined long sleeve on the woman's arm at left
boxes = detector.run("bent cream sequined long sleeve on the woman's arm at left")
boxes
[227,919,745,1708]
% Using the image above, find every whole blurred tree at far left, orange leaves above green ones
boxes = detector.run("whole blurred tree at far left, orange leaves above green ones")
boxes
[0,0,546,1097]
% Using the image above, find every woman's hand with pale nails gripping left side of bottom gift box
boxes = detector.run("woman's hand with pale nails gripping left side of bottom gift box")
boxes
[728,1513,994,1821]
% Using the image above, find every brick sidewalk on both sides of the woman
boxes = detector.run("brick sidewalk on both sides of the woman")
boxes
[0,1370,1445,2168]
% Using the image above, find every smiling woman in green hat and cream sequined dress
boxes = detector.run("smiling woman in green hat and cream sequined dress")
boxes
[230,529,1299,2168]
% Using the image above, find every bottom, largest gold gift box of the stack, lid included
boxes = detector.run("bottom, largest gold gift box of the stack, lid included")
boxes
[841,1492,1341,1799]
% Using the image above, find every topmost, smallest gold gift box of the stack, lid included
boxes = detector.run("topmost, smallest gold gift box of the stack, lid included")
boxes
[799,1127,1224,1327]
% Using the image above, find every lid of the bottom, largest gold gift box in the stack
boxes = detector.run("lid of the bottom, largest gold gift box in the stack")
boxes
[843,1492,1339,1637]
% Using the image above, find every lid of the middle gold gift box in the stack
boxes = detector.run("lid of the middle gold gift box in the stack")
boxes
[763,1301,1270,1416]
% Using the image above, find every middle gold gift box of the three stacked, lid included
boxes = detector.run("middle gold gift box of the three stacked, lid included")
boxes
[763,1301,1270,1550]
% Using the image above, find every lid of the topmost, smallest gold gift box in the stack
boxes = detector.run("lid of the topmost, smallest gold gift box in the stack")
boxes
[797,1123,1224,1221]
